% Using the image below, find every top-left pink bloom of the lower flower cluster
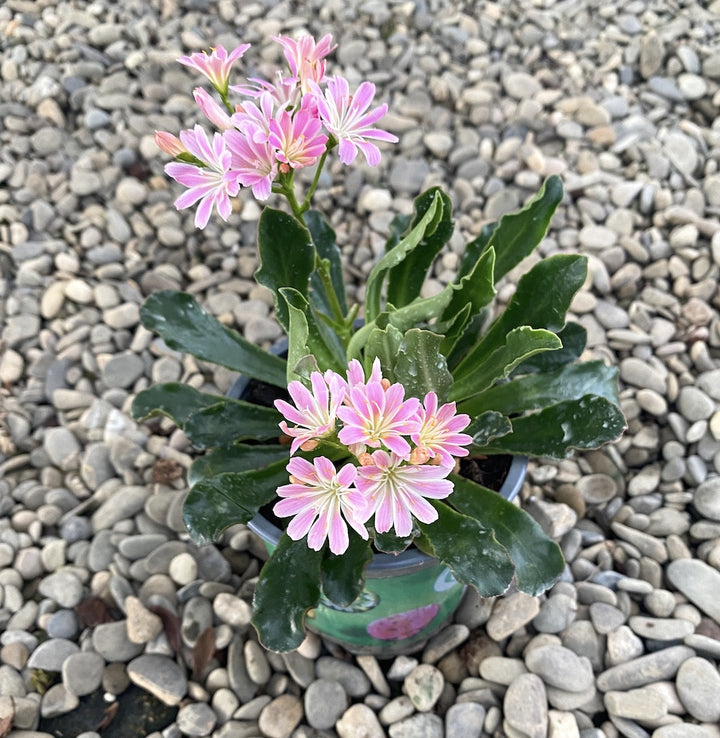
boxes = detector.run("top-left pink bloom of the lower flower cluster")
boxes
[275,370,345,454]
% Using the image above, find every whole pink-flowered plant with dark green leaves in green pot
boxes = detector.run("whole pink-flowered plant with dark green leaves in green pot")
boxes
[133,36,625,653]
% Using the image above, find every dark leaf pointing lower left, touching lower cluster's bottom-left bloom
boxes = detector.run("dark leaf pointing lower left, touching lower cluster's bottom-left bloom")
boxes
[183,460,288,545]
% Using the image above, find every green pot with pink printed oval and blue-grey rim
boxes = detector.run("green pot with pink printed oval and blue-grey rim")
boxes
[248,457,527,657]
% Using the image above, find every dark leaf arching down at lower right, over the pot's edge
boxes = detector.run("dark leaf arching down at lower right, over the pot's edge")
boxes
[448,475,565,595]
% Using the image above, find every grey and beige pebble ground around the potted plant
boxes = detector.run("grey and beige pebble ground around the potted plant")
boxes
[0,0,720,738]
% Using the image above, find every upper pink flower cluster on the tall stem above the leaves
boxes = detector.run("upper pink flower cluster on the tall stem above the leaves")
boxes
[155,35,397,228]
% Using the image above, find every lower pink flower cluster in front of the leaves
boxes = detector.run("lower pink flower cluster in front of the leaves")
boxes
[274,359,472,554]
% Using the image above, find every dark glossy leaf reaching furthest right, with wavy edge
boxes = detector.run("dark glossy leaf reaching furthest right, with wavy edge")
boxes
[483,395,626,459]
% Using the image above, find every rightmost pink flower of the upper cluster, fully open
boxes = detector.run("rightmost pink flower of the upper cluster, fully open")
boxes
[311,77,398,166]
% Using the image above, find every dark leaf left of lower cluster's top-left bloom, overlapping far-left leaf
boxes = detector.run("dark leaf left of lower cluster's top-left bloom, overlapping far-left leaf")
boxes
[183,399,282,446]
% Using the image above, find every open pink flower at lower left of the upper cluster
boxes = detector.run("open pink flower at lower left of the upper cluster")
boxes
[165,126,240,228]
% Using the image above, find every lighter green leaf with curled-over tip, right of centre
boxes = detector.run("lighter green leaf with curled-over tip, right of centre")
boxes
[450,326,562,401]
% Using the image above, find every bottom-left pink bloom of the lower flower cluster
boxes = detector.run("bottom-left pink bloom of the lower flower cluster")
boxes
[273,456,368,554]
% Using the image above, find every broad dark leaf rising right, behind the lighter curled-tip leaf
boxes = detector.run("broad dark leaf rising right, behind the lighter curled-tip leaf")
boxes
[453,254,587,377]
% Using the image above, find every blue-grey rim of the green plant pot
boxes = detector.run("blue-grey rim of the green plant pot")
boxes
[247,456,528,579]
